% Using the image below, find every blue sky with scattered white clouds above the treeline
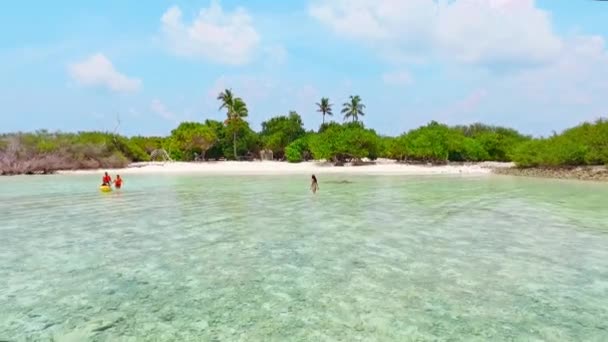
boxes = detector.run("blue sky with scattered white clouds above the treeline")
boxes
[0,0,608,136]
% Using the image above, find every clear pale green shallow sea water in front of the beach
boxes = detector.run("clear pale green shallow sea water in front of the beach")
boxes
[0,175,608,341]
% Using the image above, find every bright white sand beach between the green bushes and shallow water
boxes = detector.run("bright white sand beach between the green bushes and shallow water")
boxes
[58,160,512,175]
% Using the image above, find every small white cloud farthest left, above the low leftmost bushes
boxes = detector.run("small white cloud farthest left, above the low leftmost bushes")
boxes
[68,53,141,92]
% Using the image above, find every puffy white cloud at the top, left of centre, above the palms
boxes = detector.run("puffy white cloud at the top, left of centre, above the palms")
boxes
[161,0,260,65]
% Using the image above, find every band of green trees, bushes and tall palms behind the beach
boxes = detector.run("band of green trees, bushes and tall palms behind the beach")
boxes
[0,89,608,180]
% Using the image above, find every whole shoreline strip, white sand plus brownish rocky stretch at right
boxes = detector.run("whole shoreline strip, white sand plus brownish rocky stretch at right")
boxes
[9,159,608,182]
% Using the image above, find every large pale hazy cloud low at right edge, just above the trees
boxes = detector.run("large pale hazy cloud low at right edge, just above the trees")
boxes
[438,36,608,134]
